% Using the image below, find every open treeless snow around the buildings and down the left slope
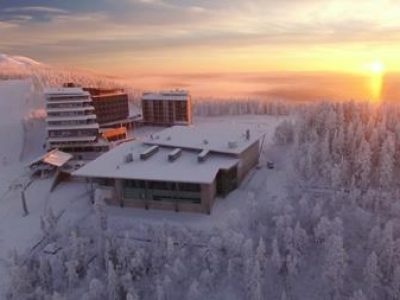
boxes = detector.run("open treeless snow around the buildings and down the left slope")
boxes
[0,80,285,299]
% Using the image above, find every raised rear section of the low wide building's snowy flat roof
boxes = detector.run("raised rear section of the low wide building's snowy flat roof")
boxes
[144,124,261,155]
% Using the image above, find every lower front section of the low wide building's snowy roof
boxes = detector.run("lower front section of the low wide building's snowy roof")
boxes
[73,141,239,184]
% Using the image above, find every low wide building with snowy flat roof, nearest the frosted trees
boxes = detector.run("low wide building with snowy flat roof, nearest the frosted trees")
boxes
[73,125,260,213]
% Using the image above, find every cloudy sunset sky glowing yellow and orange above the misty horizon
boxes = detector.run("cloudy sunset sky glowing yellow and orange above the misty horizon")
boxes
[0,0,400,99]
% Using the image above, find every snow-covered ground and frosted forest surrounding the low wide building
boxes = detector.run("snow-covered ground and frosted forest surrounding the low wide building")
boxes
[0,80,400,300]
